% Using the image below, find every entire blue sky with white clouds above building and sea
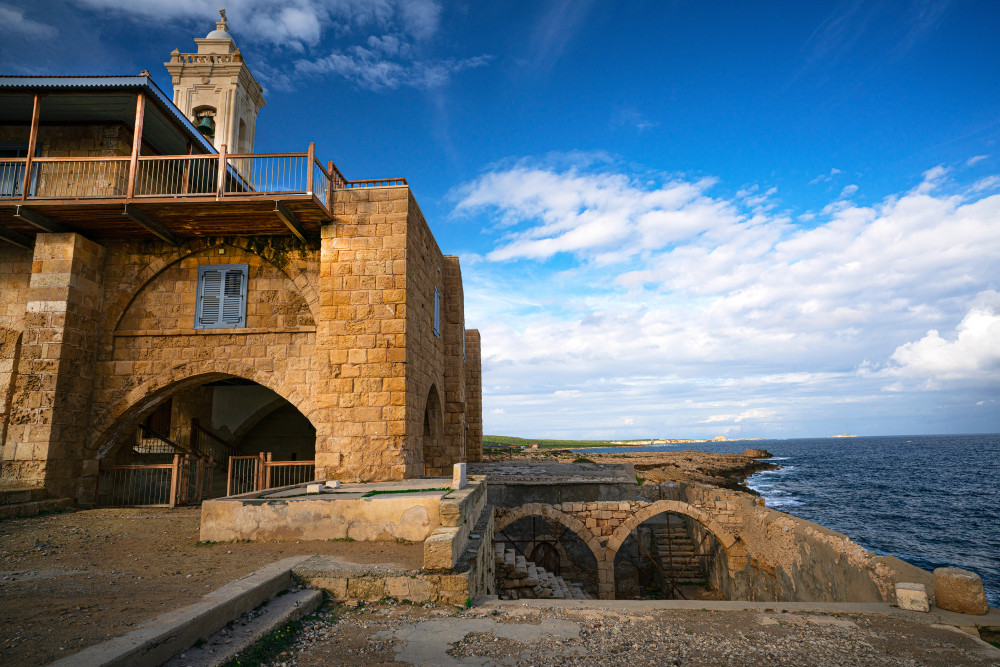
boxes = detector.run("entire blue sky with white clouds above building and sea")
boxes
[0,0,1000,439]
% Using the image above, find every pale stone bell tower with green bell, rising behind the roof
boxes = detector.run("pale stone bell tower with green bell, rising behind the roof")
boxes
[164,9,267,153]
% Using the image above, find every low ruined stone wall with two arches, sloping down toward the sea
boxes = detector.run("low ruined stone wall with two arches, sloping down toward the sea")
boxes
[495,482,932,602]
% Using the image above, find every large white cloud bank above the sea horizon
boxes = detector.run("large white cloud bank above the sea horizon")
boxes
[453,160,1000,437]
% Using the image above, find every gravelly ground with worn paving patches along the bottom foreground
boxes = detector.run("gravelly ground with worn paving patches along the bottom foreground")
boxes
[282,602,1000,667]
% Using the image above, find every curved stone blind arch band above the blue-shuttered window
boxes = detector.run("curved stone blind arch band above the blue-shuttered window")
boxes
[105,237,319,331]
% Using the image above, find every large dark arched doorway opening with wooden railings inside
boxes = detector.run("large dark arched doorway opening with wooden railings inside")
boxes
[96,373,316,504]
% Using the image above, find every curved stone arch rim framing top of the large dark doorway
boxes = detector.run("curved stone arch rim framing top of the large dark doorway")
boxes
[87,359,320,459]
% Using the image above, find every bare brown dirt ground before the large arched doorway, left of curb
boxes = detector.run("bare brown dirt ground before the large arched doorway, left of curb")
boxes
[0,507,423,665]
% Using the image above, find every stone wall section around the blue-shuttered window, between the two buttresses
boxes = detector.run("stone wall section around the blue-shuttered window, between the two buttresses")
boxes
[88,238,328,474]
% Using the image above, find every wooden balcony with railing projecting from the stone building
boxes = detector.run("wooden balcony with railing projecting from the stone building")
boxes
[0,144,406,248]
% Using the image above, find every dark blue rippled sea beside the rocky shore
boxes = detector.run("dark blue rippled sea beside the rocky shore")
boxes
[577,433,1000,607]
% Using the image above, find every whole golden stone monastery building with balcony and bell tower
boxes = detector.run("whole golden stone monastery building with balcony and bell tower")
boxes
[0,12,482,503]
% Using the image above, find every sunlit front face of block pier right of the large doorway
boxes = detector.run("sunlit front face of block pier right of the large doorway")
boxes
[316,187,412,481]
